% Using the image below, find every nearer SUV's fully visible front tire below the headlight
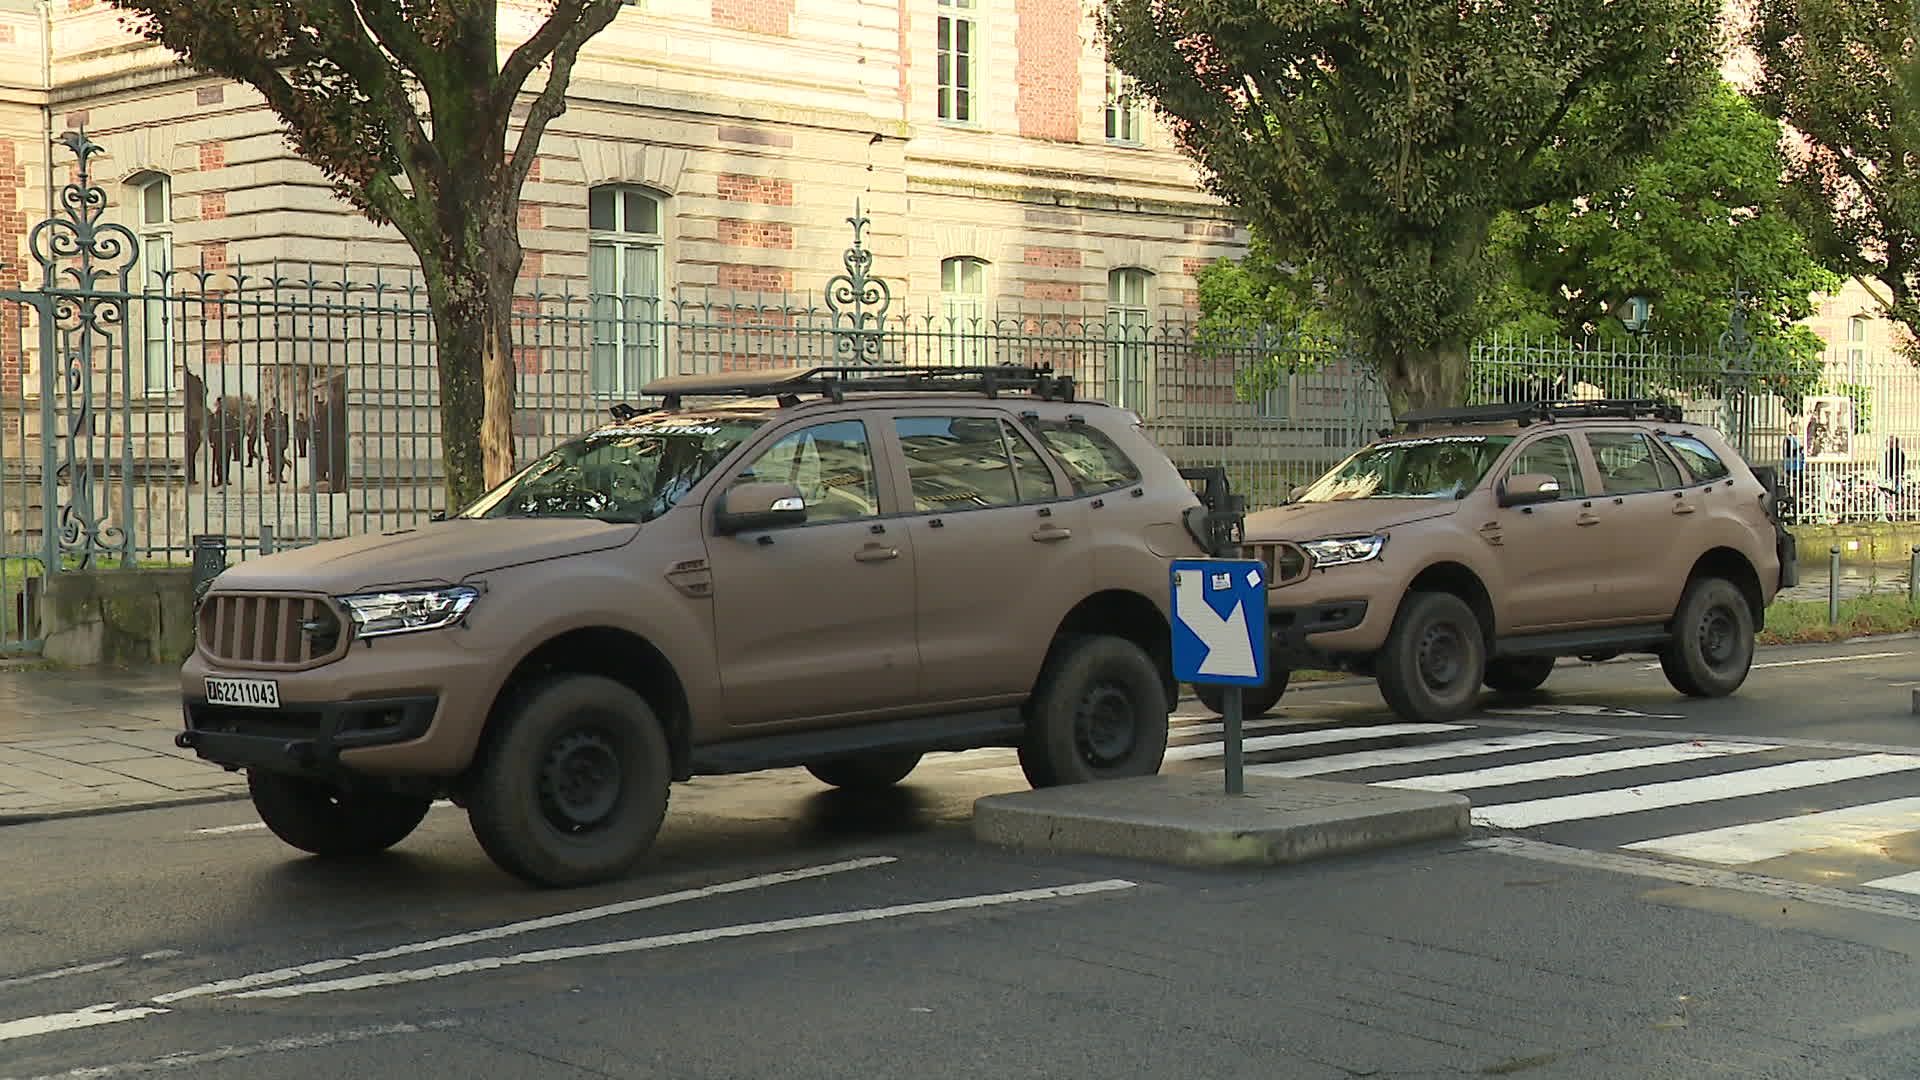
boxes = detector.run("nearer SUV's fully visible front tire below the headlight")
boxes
[467,675,672,888]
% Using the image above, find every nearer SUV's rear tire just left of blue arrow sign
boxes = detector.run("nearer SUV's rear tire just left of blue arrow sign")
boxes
[1020,636,1173,788]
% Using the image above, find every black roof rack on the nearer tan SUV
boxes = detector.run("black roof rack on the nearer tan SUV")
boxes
[620,363,1073,415]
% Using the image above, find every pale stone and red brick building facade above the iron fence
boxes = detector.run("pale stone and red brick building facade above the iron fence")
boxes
[0,0,1244,399]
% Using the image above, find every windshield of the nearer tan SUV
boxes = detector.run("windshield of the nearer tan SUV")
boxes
[461,417,762,521]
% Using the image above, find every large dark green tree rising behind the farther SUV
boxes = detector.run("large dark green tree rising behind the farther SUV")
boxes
[1100,0,1720,411]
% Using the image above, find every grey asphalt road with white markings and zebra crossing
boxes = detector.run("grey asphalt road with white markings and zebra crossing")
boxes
[0,642,1920,1080]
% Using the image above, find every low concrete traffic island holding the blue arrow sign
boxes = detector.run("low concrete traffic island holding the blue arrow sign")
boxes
[973,773,1469,867]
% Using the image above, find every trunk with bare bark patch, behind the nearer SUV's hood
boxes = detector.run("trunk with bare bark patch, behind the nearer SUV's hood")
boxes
[426,255,518,513]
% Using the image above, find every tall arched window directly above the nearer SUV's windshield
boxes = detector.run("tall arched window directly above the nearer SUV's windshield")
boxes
[588,184,666,398]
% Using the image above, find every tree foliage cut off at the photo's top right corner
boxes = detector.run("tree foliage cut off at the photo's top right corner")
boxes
[1745,0,1920,359]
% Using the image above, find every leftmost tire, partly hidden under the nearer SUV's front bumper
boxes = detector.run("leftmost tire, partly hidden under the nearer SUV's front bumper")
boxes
[246,769,432,857]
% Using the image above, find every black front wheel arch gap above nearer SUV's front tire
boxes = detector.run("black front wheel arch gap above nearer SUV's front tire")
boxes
[474,626,693,780]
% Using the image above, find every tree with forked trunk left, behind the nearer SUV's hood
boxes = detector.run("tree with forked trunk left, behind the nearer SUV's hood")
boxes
[111,0,622,505]
